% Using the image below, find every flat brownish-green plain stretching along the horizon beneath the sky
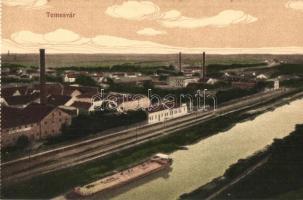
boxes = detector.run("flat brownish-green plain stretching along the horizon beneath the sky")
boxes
[2,52,303,67]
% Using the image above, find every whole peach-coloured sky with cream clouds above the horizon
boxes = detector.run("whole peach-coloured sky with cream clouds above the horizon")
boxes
[1,0,303,54]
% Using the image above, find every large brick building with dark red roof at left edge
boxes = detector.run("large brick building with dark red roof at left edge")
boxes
[1,103,71,147]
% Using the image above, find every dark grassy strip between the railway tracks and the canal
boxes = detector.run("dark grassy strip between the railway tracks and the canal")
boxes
[2,90,303,198]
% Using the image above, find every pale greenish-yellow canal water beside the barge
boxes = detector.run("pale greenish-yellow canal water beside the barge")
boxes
[96,99,303,200]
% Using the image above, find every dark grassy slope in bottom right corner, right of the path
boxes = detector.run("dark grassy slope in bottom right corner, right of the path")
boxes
[218,124,303,199]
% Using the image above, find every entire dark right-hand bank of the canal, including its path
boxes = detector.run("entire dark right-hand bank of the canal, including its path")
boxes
[180,124,303,199]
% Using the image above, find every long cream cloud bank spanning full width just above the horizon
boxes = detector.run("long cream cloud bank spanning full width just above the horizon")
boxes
[2,29,303,54]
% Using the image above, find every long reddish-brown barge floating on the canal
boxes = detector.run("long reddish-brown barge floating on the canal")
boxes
[73,153,172,197]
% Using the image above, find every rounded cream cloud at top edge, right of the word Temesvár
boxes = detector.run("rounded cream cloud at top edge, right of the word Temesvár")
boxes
[105,1,160,20]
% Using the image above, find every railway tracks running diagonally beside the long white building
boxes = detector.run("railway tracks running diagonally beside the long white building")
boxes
[1,91,294,184]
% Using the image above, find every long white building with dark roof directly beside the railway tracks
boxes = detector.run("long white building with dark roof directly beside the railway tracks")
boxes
[147,104,188,124]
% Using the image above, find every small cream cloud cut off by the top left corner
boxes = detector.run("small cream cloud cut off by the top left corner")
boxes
[2,0,48,9]
